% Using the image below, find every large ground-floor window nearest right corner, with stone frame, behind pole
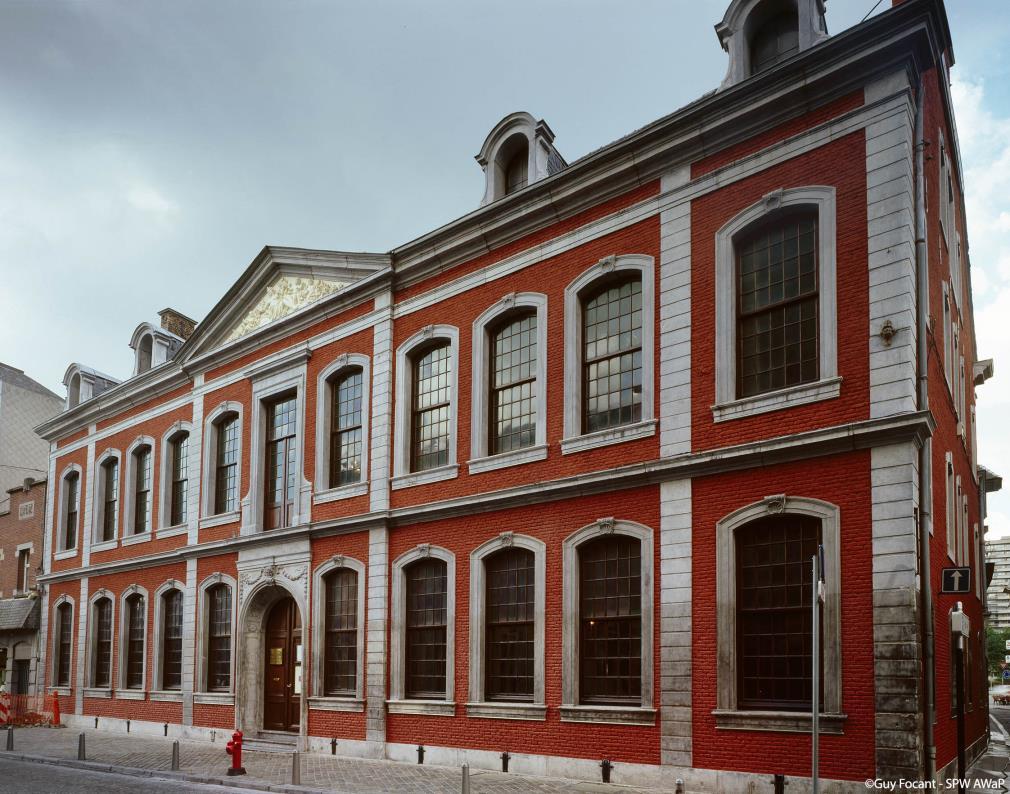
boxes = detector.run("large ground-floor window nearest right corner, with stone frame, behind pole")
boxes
[713,494,842,733]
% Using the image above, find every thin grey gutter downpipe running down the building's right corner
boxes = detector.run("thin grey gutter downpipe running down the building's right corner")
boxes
[914,74,936,780]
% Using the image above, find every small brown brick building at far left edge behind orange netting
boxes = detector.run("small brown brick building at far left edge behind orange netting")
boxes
[0,478,45,695]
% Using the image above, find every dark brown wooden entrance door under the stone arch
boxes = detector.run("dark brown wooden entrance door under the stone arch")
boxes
[263,596,302,731]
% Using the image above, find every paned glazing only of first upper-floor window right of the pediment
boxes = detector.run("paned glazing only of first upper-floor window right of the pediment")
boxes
[410,342,452,472]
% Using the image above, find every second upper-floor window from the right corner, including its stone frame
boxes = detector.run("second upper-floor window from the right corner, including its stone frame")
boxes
[562,255,655,454]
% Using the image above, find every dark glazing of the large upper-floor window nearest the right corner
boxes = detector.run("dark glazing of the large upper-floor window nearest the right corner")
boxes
[736,213,818,397]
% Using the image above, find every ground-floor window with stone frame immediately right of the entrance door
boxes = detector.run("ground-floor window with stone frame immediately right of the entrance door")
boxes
[312,555,365,708]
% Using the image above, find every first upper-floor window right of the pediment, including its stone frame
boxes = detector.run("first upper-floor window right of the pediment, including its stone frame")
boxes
[393,325,460,488]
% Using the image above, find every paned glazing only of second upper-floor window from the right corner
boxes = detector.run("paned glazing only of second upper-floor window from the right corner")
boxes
[582,276,641,432]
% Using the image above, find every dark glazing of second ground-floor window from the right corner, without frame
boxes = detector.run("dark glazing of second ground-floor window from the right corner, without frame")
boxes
[579,534,641,705]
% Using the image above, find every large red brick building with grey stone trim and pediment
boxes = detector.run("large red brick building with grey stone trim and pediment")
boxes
[33,0,993,790]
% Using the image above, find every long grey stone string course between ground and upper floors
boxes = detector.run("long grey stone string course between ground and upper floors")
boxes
[38,411,936,584]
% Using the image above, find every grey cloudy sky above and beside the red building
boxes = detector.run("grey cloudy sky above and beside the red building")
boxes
[0,0,1010,535]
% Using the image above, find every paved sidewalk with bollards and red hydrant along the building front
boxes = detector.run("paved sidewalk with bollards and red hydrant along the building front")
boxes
[0,728,646,794]
